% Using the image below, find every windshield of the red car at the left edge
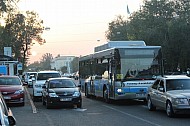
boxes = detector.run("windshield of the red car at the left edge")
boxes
[0,78,21,85]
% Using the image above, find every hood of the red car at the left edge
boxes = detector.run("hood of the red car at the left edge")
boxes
[0,85,23,92]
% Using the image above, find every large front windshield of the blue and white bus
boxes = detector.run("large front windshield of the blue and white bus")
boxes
[116,49,161,81]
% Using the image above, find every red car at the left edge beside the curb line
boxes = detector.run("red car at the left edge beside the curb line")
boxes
[0,75,25,106]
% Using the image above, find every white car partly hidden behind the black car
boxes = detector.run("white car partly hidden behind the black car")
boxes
[33,71,61,101]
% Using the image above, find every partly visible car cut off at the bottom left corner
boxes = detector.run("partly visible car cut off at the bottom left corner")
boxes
[0,93,16,126]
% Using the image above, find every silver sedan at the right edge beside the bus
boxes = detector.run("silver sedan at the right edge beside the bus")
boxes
[147,75,190,117]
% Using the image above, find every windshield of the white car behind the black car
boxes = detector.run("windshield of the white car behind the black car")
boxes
[37,73,61,80]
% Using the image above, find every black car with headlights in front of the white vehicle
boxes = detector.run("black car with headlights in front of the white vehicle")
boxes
[42,77,82,109]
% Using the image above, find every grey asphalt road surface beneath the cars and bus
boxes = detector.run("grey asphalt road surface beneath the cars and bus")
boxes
[10,80,190,126]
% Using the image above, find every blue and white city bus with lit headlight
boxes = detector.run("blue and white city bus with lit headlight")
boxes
[79,41,163,102]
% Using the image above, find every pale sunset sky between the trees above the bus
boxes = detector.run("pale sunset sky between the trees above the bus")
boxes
[18,0,143,63]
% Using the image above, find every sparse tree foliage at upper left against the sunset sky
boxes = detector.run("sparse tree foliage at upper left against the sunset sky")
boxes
[0,0,45,73]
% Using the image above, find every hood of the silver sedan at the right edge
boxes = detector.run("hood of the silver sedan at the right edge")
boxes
[168,90,190,98]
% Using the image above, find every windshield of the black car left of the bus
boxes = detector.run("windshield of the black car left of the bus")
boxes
[49,79,76,88]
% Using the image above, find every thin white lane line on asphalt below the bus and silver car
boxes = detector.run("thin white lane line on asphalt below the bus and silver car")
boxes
[103,105,161,126]
